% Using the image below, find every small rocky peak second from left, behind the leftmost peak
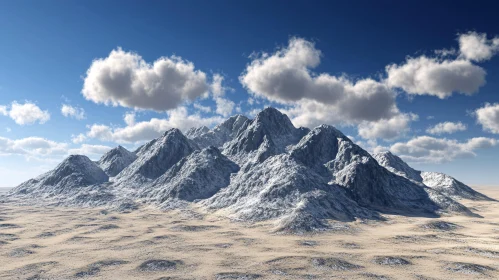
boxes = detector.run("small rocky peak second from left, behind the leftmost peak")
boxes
[99,146,137,177]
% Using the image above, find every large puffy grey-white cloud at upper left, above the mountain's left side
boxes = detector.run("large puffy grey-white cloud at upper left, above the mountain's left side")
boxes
[82,48,210,111]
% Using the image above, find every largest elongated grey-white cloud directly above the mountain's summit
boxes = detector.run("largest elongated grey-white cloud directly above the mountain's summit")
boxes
[239,38,396,121]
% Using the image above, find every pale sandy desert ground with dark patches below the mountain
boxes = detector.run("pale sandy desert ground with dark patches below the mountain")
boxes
[0,187,499,279]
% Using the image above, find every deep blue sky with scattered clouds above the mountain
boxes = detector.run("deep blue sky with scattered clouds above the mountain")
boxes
[0,1,499,187]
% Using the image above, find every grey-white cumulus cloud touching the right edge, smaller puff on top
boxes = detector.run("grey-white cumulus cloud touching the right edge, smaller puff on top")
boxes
[385,32,499,99]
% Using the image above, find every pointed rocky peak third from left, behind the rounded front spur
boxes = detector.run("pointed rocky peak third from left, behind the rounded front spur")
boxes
[115,128,197,188]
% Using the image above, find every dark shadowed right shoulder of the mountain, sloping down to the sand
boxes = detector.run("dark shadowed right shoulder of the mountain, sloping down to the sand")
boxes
[290,125,466,214]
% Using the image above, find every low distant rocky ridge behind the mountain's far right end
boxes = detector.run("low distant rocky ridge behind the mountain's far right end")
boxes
[373,152,492,200]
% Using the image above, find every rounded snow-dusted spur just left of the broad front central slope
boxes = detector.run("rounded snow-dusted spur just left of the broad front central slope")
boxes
[139,147,239,208]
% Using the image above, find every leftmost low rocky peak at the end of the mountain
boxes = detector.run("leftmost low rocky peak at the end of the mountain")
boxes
[11,155,109,197]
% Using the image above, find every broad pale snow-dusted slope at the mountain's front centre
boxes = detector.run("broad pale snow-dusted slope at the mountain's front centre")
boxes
[202,154,378,231]
